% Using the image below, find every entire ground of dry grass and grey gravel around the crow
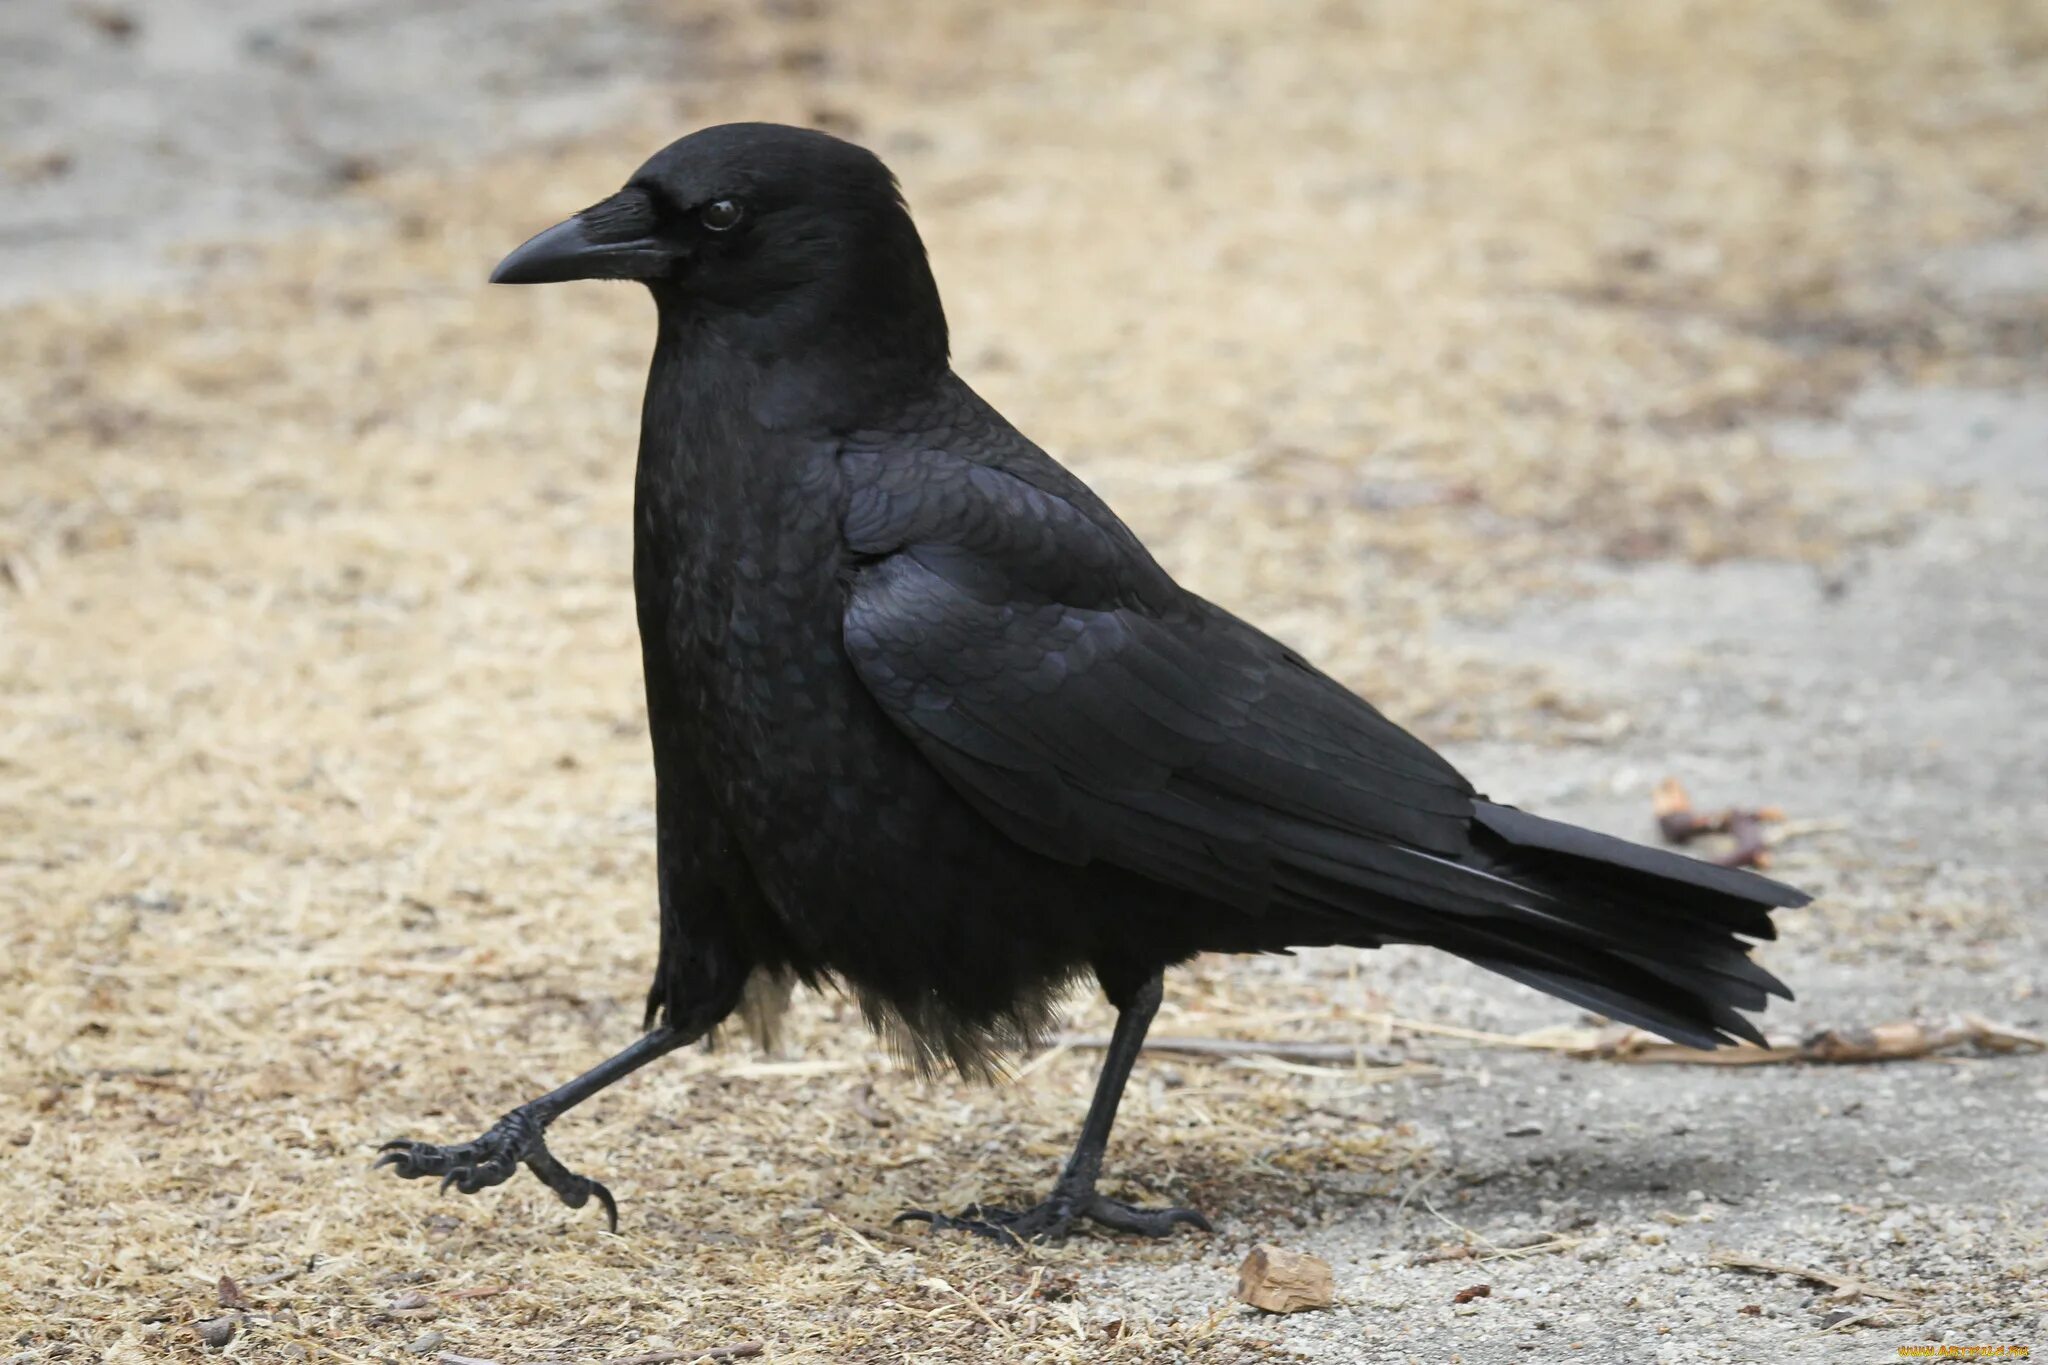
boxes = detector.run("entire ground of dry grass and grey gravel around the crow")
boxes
[0,0,2048,1365]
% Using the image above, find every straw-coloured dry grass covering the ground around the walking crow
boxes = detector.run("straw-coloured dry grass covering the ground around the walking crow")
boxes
[12,0,2048,1361]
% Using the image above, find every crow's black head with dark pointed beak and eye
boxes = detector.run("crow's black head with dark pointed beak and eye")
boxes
[492,123,946,374]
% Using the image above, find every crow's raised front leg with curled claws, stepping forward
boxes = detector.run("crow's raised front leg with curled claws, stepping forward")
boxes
[377,1025,696,1232]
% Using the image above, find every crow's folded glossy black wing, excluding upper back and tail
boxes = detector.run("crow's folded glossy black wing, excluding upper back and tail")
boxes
[844,523,1473,911]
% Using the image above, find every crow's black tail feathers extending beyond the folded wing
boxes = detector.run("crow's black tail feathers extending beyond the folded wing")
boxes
[1436,800,1810,1048]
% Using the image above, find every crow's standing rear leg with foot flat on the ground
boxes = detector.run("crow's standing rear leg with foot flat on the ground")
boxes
[895,972,1208,1244]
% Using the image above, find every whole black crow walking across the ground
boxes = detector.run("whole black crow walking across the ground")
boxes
[383,123,1806,1238]
